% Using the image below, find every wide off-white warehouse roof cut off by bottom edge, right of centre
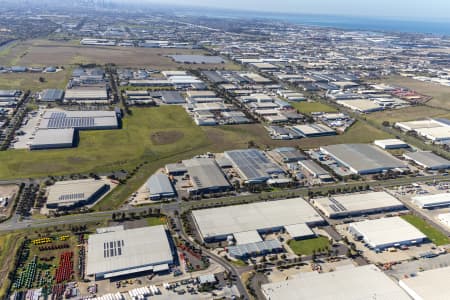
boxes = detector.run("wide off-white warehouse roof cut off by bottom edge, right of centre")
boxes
[261,265,410,300]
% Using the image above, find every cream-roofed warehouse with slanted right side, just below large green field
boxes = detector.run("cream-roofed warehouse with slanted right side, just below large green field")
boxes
[47,179,110,209]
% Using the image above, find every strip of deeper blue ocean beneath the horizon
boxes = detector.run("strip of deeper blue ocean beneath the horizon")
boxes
[178,9,450,36]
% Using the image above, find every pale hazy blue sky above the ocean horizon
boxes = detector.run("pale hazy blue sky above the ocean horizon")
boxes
[140,0,450,21]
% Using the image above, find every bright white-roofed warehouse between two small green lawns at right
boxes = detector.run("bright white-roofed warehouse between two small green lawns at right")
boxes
[348,217,426,250]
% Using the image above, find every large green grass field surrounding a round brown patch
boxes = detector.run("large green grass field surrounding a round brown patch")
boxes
[0,106,209,179]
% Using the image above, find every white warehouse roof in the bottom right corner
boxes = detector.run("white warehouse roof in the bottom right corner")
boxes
[399,267,450,300]
